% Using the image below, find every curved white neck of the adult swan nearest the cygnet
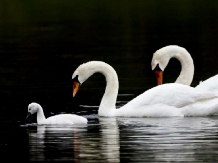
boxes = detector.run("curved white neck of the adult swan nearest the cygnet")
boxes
[89,62,119,116]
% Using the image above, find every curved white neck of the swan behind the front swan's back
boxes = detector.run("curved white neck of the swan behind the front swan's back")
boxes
[172,49,194,85]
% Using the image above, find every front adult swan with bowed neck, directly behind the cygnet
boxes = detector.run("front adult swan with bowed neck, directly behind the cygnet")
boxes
[72,61,218,117]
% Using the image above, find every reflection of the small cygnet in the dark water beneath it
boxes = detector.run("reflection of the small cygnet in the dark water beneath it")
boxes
[29,126,86,162]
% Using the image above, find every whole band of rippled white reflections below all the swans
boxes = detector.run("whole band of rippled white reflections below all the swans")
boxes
[29,117,218,162]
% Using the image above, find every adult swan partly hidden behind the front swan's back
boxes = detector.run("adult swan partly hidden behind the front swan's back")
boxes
[151,45,218,95]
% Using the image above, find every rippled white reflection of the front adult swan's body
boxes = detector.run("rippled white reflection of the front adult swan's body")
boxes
[118,117,218,162]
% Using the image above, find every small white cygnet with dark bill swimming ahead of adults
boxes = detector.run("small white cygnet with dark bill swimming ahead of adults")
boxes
[27,102,87,125]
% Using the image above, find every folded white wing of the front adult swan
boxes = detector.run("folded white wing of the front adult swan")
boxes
[124,83,216,108]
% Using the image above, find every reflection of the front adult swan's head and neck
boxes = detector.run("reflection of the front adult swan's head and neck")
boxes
[75,118,120,163]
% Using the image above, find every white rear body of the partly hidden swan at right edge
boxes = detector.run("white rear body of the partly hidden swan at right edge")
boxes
[195,75,218,95]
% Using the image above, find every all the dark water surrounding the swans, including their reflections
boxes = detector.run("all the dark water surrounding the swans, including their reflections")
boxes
[0,0,218,162]
